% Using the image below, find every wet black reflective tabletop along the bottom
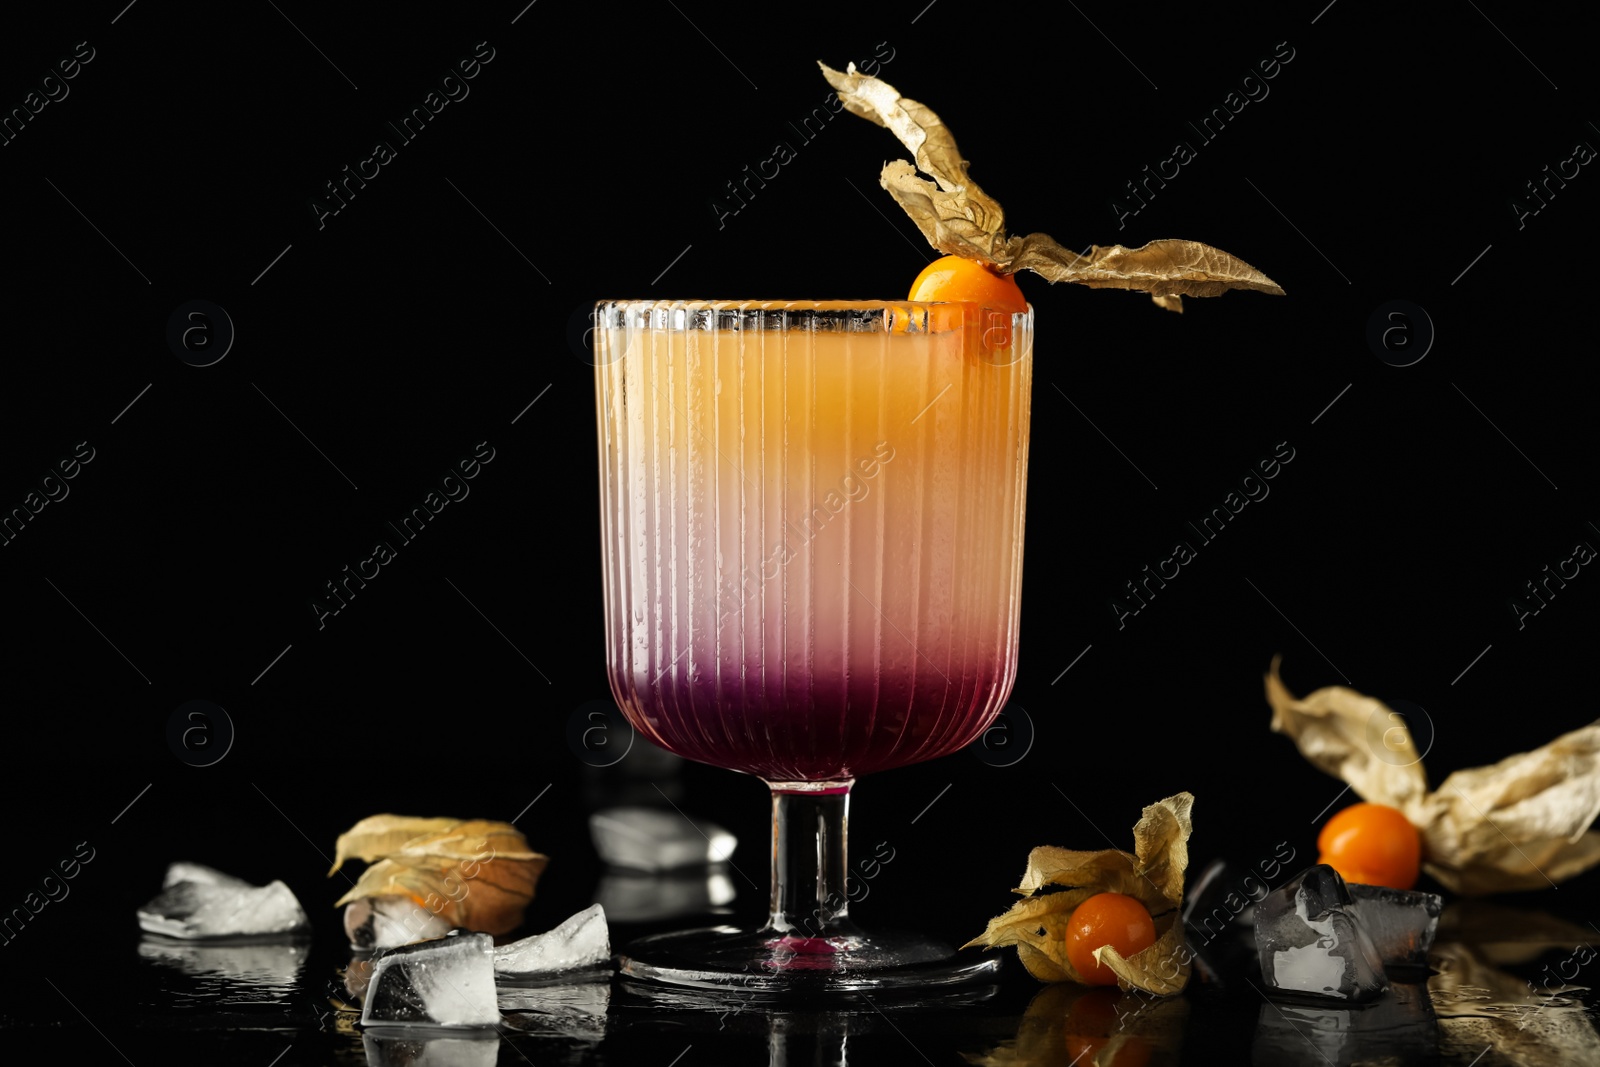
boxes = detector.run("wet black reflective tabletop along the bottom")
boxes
[3,883,1600,1067]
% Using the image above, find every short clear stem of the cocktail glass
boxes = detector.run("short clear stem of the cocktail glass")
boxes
[766,781,854,937]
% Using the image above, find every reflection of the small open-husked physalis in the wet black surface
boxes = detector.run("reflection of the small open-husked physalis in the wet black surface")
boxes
[962,985,1189,1067]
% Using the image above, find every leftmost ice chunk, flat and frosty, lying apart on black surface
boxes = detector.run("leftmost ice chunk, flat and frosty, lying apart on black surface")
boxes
[139,864,309,941]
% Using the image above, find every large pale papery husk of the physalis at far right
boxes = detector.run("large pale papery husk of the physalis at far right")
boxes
[1266,657,1600,896]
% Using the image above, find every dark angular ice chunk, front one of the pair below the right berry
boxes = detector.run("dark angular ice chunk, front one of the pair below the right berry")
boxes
[1256,864,1389,1003]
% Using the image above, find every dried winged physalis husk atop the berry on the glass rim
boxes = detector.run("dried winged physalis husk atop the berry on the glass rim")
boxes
[818,64,1283,312]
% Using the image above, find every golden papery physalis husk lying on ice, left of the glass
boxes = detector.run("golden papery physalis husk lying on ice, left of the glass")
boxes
[328,814,549,934]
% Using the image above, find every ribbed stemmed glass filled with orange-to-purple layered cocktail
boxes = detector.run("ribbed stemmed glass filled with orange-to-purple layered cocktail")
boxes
[595,295,1032,987]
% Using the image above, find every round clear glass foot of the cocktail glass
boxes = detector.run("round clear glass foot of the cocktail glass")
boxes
[619,926,1000,993]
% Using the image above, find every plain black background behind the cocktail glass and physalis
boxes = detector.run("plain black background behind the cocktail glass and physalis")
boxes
[0,0,1600,1062]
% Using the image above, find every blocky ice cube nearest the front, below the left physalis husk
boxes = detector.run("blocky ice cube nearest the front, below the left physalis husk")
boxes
[362,933,499,1027]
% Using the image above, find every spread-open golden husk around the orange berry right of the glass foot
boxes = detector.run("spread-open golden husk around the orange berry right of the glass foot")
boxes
[962,793,1195,997]
